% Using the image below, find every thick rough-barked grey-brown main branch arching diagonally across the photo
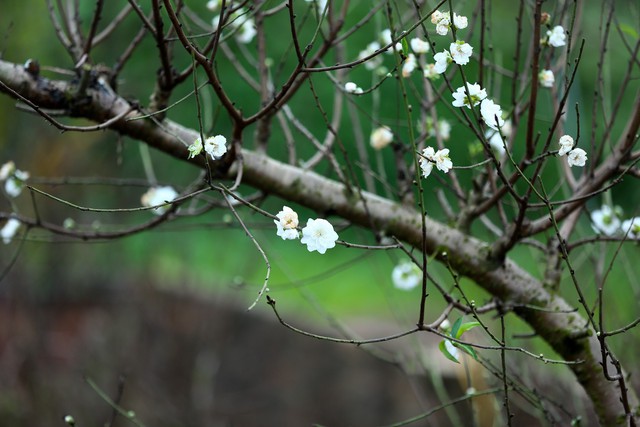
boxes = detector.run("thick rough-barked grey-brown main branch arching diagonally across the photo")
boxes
[0,61,638,425]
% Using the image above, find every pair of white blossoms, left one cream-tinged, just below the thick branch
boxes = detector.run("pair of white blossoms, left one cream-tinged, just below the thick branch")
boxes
[273,206,338,254]
